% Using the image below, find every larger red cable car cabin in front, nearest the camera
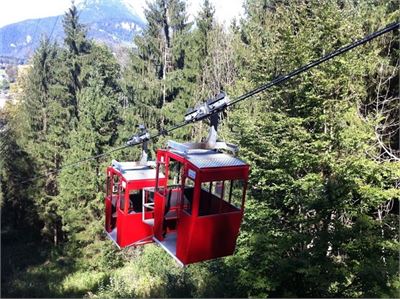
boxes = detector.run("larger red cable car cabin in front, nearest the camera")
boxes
[150,141,249,265]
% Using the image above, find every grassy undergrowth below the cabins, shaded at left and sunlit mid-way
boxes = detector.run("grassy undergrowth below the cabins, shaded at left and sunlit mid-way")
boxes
[1,228,208,298]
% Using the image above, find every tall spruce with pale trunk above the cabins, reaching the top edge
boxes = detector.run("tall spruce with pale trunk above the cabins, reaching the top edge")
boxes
[125,0,190,135]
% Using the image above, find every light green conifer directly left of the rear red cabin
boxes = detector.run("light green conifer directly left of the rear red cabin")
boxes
[57,45,120,251]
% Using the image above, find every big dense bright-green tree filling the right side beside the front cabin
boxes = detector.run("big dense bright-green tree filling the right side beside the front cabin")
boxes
[231,1,399,297]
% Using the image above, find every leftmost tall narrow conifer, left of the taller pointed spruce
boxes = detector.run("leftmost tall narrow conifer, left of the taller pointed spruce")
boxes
[17,38,69,243]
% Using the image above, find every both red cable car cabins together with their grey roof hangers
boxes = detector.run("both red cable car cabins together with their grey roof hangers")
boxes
[105,93,249,265]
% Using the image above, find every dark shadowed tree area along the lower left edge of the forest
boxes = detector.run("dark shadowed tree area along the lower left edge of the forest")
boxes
[1,146,76,298]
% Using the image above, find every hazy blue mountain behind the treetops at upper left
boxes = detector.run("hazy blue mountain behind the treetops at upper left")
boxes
[0,0,145,59]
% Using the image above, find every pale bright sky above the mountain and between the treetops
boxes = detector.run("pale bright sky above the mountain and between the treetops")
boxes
[0,0,243,27]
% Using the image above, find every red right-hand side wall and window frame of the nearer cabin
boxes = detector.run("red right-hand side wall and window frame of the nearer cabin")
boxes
[177,166,249,264]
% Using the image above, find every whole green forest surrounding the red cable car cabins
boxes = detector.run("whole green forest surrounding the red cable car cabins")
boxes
[0,0,400,298]
